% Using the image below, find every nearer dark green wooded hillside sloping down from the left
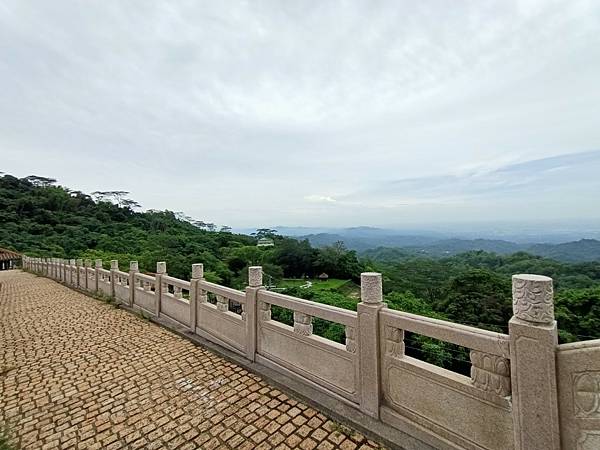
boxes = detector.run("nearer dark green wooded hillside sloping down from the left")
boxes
[0,175,361,287]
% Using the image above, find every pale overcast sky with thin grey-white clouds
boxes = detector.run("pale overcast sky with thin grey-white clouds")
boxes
[0,0,600,227]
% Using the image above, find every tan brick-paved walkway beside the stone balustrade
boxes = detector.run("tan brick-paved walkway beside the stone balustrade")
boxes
[0,271,379,450]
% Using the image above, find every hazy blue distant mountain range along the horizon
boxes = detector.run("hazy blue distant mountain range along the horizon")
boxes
[297,228,600,262]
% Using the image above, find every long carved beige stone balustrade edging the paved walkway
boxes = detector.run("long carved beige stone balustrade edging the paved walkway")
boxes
[23,257,600,450]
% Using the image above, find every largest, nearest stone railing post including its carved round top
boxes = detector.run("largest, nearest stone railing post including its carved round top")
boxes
[508,275,560,450]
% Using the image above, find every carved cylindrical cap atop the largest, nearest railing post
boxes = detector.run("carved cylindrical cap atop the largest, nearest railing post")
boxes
[513,275,554,323]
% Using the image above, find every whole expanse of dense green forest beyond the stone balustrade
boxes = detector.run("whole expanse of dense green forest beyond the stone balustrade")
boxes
[0,175,600,372]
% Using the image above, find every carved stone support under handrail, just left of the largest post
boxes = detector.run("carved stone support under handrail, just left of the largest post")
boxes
[470,350,511,397]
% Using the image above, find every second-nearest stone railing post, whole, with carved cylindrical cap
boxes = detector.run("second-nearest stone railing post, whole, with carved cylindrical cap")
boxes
[357,272,385,418]
